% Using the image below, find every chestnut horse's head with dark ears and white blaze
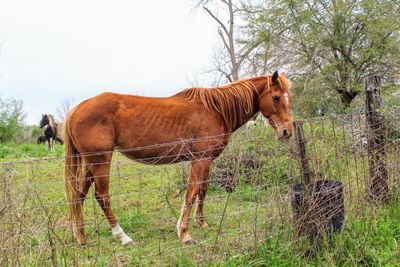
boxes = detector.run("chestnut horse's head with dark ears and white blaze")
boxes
[259,71,293,140]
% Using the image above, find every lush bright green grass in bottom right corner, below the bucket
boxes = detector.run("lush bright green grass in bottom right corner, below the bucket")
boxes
[217,201,400,266]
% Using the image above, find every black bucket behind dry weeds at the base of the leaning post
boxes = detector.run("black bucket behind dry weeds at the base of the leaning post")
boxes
[291,180,345,237]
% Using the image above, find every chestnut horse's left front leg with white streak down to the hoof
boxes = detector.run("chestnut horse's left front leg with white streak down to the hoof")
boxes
[177,159,211,244]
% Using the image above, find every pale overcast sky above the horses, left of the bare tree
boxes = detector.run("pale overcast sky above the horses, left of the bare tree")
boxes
[0,0,218,124]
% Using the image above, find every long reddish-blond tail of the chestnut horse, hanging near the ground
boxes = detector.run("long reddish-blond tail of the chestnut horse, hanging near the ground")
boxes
[64,119,85,244]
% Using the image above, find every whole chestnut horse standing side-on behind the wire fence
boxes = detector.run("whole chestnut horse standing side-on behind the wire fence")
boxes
[64,72,293,245]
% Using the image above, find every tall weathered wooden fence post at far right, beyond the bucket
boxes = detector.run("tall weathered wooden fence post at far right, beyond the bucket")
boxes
[364,76,389,203]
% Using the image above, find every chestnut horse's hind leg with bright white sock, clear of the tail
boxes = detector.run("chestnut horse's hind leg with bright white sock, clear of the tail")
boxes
[92,154,133,246]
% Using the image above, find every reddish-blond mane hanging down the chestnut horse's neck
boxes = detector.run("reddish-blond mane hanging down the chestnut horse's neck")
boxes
[182,79,258,129]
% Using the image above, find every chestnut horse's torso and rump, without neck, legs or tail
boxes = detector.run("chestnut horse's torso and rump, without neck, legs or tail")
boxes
[67,93,228,160]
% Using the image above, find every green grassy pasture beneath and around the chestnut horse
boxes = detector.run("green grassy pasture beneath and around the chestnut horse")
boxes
[0,122,400,266]
